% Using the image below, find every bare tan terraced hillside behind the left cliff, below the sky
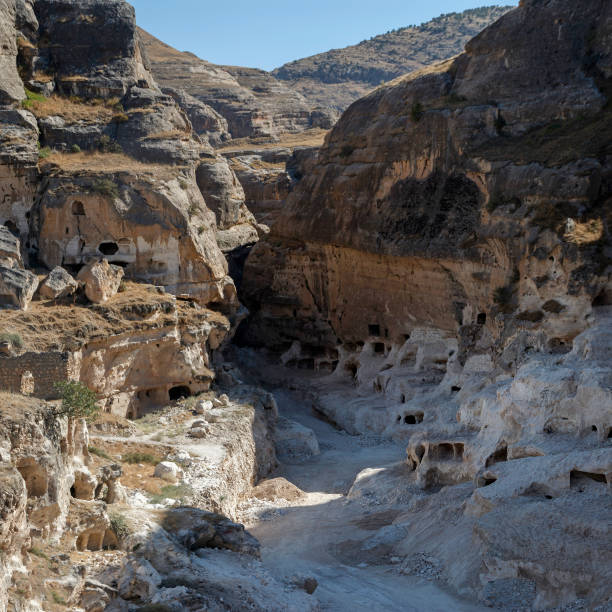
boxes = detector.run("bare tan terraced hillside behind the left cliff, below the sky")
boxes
[139,30,335,138]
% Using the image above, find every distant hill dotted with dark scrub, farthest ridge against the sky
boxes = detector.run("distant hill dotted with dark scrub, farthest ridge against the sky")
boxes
[272,6,512,111]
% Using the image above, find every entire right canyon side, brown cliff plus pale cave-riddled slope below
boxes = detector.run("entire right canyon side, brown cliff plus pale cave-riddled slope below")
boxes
[242,0,612,609]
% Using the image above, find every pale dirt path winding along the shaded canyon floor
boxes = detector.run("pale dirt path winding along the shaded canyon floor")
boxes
[249,391,486,612]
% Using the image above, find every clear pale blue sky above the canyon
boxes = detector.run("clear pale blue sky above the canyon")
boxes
[128,0,518,70]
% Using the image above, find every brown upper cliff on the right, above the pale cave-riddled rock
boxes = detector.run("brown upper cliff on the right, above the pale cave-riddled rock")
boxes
[243,0,612,350]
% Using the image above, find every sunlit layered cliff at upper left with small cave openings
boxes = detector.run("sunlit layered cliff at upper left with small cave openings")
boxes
[0,0,258,308]
